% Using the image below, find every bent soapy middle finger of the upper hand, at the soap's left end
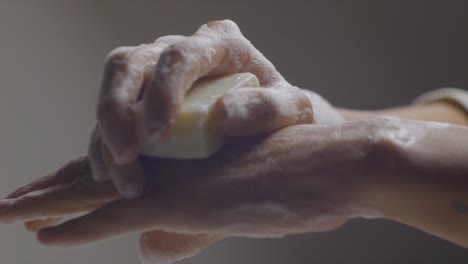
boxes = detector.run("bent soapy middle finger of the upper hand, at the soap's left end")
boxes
[97,36,183,164]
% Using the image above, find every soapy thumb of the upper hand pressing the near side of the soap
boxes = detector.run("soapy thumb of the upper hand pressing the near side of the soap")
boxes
[213,87,314,136]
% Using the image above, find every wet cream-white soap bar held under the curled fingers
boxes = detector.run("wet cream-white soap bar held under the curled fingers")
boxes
[137,73,260,159]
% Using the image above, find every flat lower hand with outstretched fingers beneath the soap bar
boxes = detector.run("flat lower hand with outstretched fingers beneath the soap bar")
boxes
[0,119,401,259]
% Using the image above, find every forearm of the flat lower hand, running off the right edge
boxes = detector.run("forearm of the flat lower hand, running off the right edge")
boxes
[373,120,468,247]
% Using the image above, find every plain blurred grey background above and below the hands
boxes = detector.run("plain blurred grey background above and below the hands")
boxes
[0,0,468,264]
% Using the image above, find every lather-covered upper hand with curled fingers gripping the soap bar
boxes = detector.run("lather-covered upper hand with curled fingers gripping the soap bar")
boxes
[92,20,314,198]
